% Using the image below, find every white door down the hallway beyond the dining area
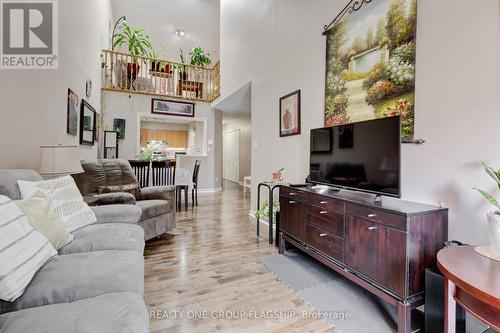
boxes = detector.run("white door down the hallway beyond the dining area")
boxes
[222,129,240,183]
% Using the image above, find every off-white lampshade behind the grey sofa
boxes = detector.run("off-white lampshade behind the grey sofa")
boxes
[40,145,83,177]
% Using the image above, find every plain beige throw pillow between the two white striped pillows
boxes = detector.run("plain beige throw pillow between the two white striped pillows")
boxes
[15,192,74,250]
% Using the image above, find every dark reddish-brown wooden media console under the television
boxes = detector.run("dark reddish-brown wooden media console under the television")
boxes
[279,186,448,333]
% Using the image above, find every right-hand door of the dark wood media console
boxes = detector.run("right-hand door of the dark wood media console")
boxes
[377,226,406,296]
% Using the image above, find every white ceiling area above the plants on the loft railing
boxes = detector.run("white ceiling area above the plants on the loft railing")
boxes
[111,0,220,63]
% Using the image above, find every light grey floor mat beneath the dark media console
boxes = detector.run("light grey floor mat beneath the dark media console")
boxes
[262,251,417,333]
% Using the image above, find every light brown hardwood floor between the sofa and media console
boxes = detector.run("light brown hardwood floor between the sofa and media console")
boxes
[145,183,335,332]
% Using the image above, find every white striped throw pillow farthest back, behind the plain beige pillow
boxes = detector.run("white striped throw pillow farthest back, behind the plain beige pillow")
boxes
[17,176,97,232]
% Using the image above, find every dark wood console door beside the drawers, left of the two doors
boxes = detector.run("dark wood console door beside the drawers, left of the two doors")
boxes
[344,216,378,279]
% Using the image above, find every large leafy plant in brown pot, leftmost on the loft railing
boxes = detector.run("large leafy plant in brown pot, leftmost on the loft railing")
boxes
[113,23,152,78]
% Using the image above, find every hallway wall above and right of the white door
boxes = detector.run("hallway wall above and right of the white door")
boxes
[222,115,252,182]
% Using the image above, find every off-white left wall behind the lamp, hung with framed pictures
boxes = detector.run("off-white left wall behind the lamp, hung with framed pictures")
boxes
[0,0,112,169]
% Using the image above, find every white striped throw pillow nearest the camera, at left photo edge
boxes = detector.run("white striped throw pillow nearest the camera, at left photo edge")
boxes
[0,195,57,302]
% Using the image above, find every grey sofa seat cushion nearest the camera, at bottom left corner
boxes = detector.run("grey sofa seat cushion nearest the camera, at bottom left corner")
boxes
[0,292,149,333]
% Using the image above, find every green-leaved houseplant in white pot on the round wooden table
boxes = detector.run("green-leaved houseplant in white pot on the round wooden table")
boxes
[476,163,500,257]
